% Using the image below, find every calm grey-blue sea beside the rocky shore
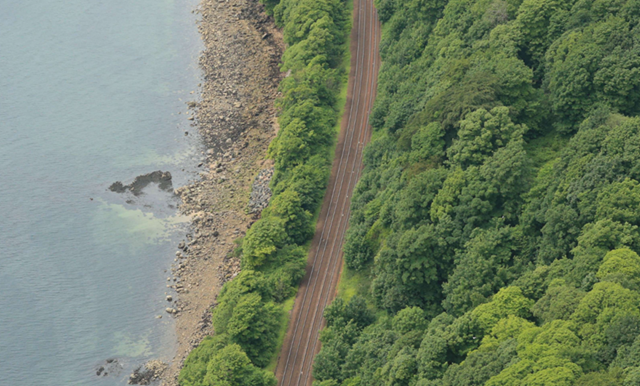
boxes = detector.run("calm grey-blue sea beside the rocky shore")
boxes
[0,0,202,386]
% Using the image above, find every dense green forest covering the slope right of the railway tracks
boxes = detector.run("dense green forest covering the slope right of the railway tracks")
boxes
[314,0,640,386]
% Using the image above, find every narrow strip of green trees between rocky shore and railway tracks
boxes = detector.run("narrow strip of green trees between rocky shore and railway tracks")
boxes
[179,0,352,386]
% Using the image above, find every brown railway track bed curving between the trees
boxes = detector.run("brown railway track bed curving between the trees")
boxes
[276,0,380,386]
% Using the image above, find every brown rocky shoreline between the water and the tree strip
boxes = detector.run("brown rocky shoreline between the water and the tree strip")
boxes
[162,0,284,386]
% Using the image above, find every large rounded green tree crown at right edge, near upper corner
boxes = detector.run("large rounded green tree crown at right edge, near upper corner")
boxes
[546,15,639,130]
